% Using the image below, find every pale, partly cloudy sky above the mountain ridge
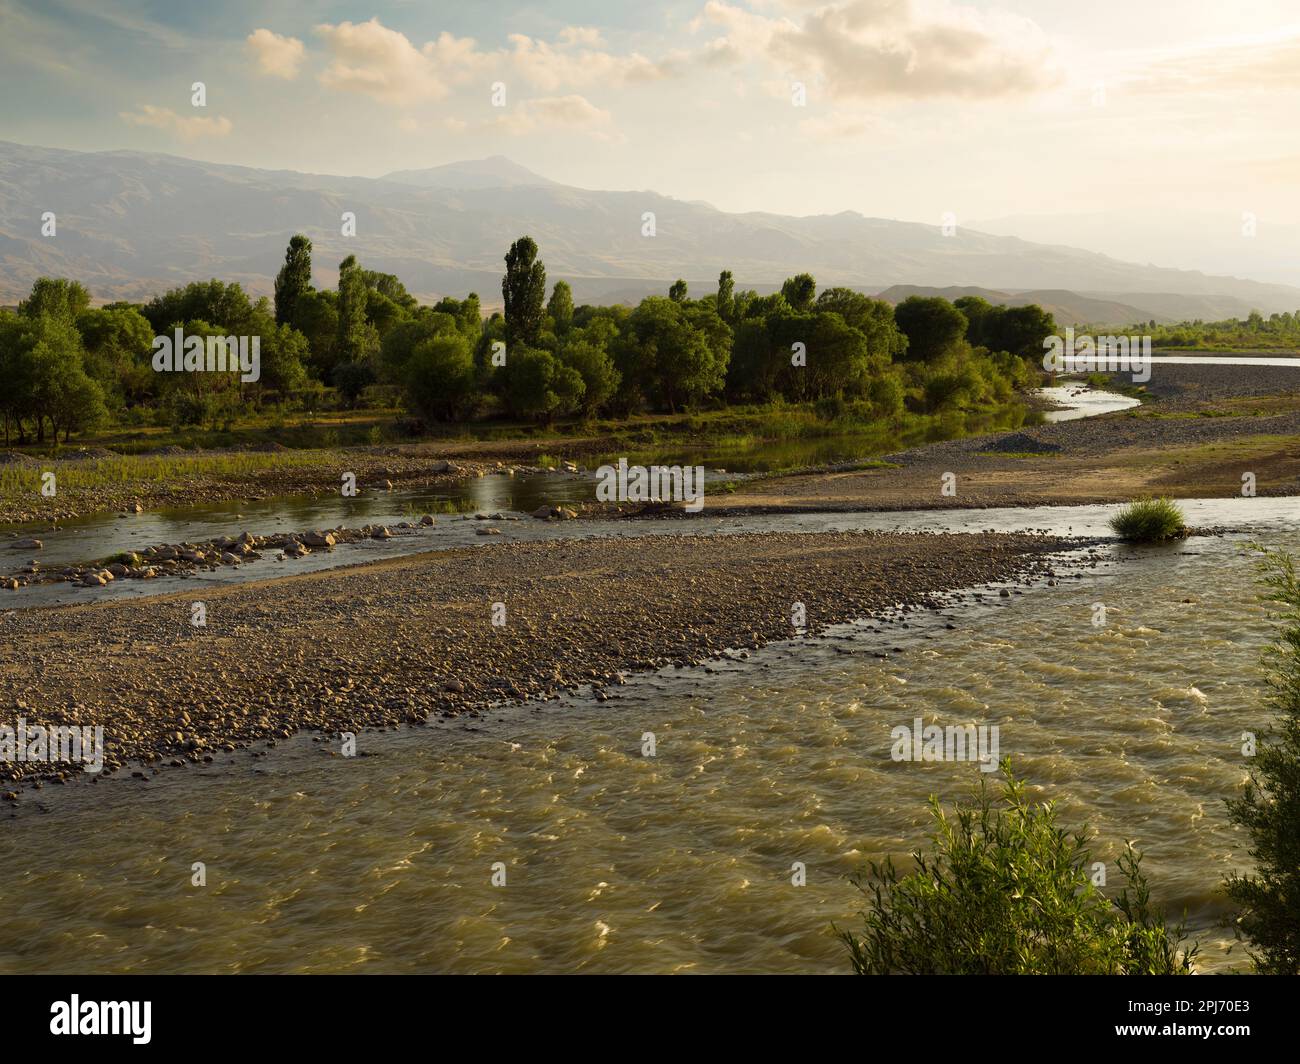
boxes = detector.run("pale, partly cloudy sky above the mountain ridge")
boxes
[0,0,1300,249]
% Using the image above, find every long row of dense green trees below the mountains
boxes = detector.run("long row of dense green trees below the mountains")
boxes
[0,234,1056,442]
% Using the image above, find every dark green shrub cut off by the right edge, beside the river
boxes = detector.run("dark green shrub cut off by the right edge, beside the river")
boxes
[1225,550,1300,976]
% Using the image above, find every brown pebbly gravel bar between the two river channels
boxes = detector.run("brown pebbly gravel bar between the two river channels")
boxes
[0,533,1067,800]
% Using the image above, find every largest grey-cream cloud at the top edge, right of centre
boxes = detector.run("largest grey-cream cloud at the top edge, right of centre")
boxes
[692,0,1061,100]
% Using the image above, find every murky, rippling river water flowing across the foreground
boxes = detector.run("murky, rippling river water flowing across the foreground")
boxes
[0,385,1300,973]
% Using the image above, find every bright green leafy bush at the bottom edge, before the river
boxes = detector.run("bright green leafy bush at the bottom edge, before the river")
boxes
[840,762,1197,976]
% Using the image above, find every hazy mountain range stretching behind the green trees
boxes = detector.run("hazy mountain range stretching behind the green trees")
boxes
[0,142,1300,319]
